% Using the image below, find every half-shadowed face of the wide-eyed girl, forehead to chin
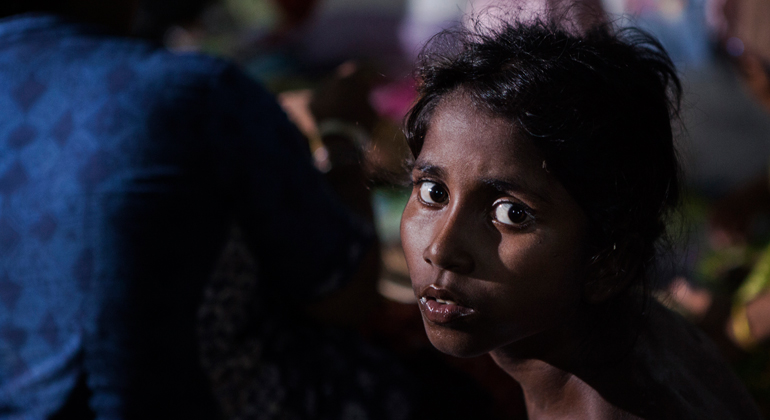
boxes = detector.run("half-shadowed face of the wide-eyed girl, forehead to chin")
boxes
[401,93,587,357]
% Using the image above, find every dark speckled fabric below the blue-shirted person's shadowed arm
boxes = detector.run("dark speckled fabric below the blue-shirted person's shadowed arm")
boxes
[199,230,419,420]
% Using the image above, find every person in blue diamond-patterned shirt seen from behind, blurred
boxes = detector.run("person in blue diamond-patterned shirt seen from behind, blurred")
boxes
[0,0,396,419]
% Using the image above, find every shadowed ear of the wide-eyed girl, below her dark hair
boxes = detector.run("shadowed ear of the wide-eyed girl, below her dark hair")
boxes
[583,244,638,305]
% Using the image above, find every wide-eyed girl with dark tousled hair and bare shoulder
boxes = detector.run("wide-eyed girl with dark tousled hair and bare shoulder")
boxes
[401,21,760,419]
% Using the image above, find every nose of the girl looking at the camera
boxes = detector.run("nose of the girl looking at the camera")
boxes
[422,210,475,275]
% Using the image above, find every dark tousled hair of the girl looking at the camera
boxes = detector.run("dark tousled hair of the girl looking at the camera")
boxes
[405,19,682,298]
